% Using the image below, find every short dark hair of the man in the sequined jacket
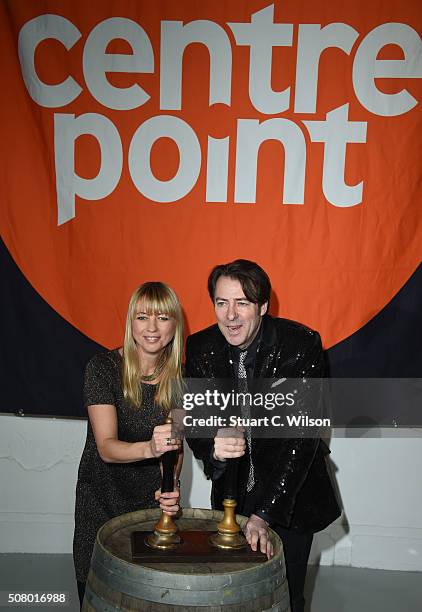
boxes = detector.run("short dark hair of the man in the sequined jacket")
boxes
[208,259,271,306]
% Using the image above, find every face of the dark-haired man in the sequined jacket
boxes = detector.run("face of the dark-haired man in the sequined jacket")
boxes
[214,276,268,349]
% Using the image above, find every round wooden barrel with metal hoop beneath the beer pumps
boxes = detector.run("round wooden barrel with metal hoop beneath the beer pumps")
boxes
[82,508,290,612]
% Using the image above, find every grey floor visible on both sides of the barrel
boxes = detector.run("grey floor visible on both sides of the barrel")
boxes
[0,554,422,612]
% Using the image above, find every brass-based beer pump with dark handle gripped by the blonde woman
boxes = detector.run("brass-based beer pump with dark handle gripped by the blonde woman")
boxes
[145,417,182,550]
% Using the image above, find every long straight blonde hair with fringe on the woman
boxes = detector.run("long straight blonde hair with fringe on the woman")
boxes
[122,282,183,411]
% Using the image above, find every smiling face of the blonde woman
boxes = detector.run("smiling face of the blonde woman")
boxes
[132,302,176,358]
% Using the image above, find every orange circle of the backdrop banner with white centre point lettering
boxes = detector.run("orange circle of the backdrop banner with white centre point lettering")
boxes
[0,0,422,347]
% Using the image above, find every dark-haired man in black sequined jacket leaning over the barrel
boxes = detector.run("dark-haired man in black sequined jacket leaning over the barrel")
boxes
[186,259,340,612]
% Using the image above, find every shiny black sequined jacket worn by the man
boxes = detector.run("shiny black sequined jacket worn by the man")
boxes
[186,315,340,532]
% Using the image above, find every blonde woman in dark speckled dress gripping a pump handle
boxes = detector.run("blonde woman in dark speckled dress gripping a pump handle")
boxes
[73,282,183,603]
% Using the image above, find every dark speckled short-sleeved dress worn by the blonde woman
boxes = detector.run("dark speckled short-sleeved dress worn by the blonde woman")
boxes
[73,350,165,582]
